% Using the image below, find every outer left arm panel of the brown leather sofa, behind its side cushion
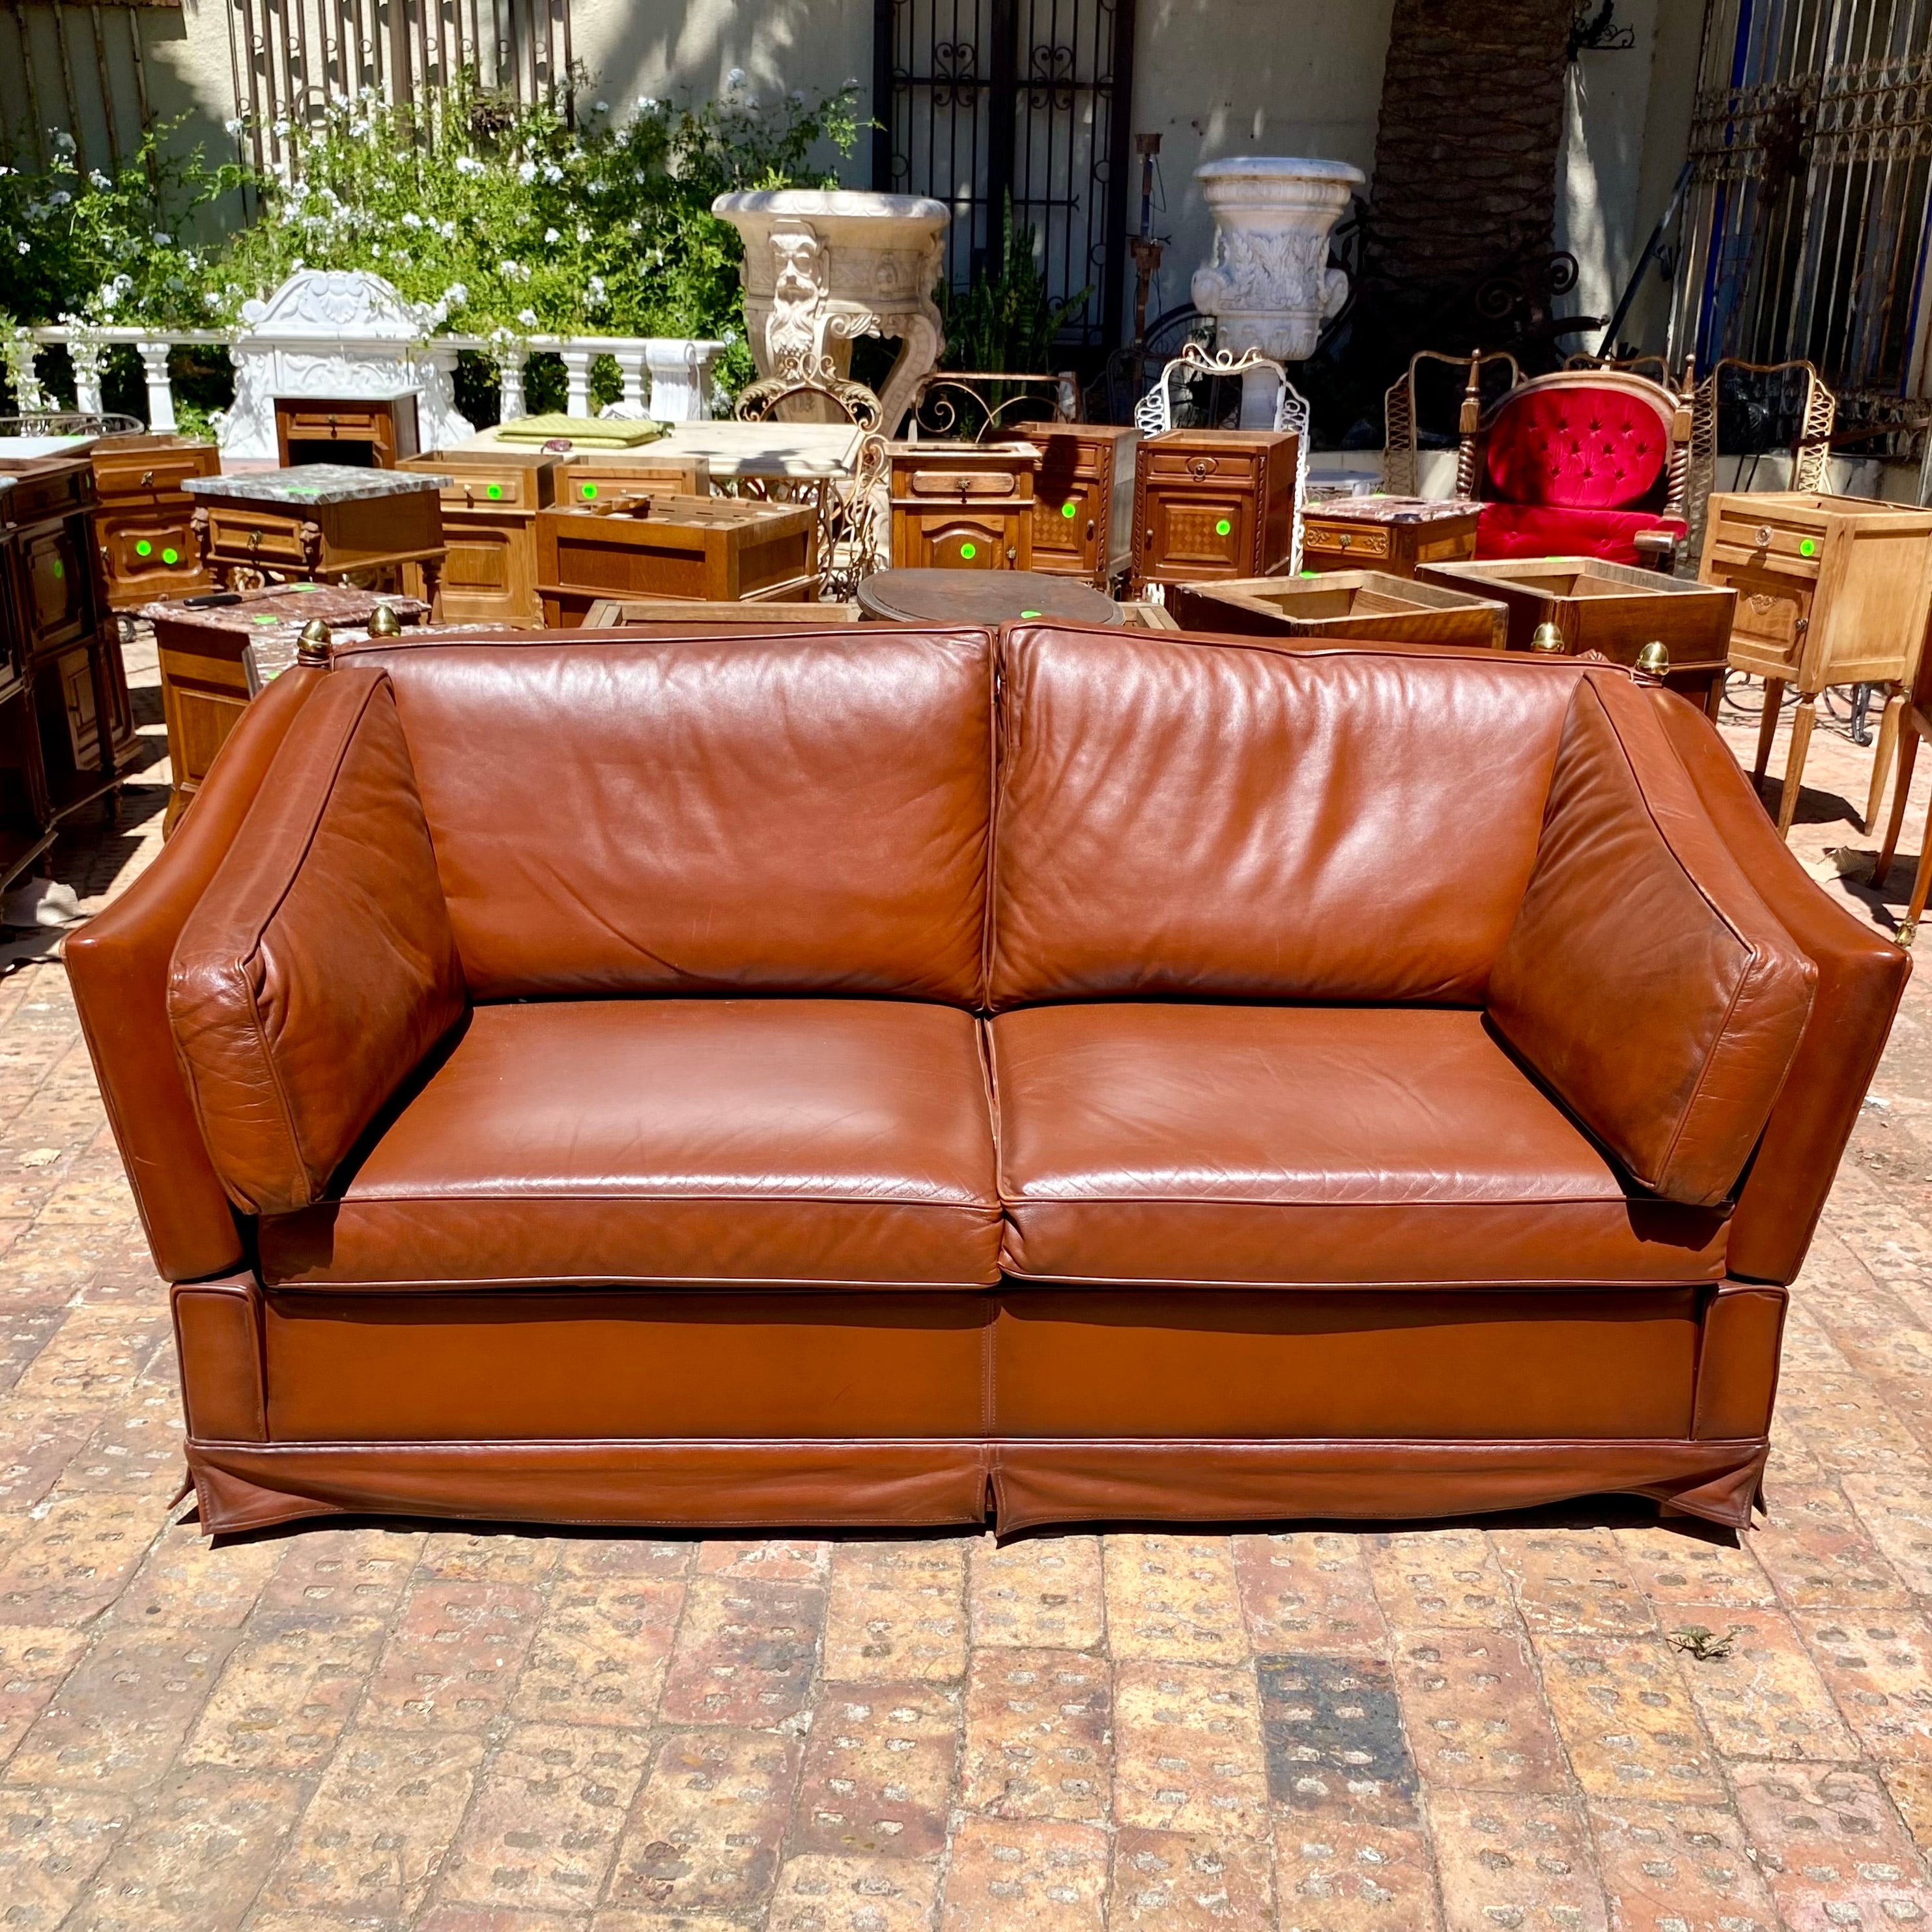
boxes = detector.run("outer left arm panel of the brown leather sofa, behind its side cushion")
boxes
[62,664,322,1281]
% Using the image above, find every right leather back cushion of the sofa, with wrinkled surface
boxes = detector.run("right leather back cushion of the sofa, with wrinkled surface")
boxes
[991,628,1578,1008]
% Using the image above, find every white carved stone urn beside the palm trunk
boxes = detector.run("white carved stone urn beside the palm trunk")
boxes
[1192,154,1368,427]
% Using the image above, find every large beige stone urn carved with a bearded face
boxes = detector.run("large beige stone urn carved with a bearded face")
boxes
[711,188,952,429]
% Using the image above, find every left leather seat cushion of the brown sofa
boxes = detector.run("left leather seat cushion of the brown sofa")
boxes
[261,999,1001,1288]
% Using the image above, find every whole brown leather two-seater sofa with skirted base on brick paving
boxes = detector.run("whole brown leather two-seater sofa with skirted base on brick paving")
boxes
[68,626,1907,1530]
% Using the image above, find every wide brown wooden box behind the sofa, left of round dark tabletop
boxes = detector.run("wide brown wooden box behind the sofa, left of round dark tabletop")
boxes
[537,496,817,630]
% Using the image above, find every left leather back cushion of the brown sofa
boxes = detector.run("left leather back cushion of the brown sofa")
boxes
[340,628,993,1004]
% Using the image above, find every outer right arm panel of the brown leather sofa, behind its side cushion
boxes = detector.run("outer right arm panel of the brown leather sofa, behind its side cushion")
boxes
[1650,692,1912,1283]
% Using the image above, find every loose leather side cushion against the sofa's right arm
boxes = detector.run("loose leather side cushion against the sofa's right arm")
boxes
[1488,674,1818,1206]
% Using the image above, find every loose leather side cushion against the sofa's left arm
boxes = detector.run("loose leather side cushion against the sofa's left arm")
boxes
[168,668,466,1215]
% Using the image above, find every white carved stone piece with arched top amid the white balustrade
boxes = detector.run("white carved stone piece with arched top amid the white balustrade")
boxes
[222,268,476,464]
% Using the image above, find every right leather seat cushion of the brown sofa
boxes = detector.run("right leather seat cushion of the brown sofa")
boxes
[991,1004,1726,1286]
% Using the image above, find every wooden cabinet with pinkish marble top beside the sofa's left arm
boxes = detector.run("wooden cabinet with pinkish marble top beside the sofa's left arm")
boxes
[139,584,429,834]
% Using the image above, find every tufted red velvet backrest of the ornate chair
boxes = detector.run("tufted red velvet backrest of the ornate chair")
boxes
[1482,384,1671,510]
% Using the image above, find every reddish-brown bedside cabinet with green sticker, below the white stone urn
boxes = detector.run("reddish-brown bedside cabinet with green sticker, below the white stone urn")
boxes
[1134,429,1300,584]
